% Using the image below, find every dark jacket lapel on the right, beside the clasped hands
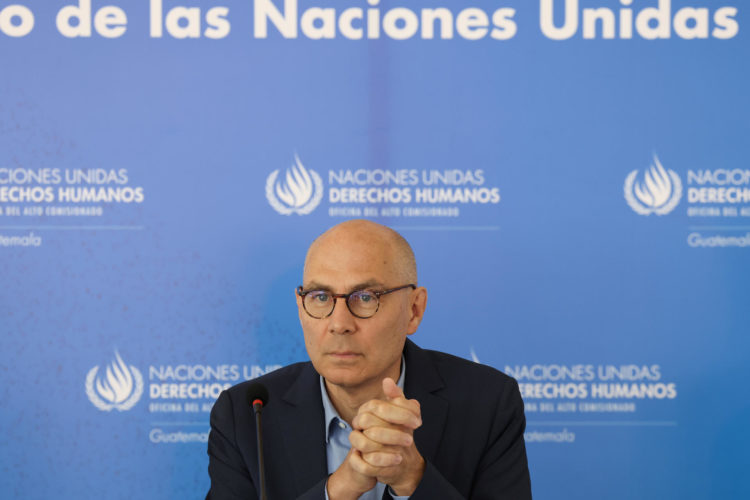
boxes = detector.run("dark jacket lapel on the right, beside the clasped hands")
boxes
[404,339,449,463]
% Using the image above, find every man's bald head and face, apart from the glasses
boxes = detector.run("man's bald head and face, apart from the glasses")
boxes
[297,220,427,390]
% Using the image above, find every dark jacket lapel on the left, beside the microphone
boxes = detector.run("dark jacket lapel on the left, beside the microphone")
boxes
[279,363,328,495]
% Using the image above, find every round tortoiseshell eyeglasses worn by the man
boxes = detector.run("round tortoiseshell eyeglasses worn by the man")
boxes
[297,283,417,319]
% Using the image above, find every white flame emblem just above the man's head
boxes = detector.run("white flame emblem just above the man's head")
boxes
[266,155,323,215]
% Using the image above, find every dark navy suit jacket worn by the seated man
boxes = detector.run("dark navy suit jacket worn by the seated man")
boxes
[206,340,531,500]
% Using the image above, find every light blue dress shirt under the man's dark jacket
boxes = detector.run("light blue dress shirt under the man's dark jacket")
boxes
[320,356,409,500]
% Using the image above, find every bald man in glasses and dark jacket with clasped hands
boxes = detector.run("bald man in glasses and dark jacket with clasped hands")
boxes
[207,220,531,500]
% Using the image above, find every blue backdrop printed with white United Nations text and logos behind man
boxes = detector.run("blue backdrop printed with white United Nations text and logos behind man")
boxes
[0,0,750,499]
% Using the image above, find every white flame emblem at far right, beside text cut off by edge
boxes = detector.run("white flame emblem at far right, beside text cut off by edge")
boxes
[624,155,682,215]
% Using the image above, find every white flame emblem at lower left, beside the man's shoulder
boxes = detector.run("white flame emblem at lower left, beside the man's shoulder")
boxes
[86,351,143,411]
